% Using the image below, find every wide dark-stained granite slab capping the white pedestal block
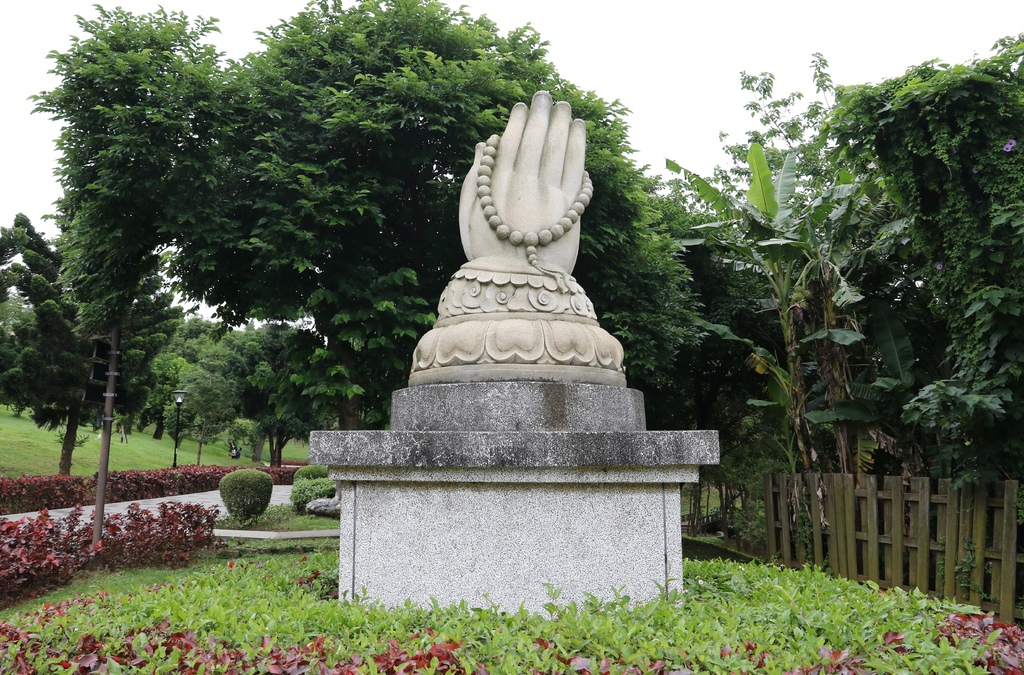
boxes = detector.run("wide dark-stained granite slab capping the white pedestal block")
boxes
[309,431,719,468]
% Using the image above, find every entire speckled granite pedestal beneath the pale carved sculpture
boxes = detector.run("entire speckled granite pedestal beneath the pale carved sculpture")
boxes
[310,381,718,610]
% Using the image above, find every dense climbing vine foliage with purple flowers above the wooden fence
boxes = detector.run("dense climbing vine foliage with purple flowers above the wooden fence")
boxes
[828,38,1024,479]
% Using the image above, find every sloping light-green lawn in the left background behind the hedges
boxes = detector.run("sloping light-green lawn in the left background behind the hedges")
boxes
[0,406,309,476]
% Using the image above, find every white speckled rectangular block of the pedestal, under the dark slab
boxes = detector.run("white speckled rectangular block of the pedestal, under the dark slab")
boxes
[332,475,682,611]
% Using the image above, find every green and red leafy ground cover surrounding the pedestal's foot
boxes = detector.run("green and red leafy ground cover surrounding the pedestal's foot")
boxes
[0,550,1020,675]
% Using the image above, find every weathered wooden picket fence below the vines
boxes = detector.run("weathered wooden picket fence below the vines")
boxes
[765,473,1024,623]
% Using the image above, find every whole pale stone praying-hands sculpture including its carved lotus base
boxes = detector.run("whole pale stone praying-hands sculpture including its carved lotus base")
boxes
[409,91,626,386]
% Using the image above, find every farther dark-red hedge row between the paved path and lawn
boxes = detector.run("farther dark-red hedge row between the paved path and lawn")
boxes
[0,464,297,515]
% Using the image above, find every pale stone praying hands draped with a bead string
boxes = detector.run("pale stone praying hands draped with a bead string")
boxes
[459,91,593,278]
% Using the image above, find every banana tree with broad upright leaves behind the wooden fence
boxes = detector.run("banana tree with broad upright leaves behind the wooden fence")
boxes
[669,143,881,472]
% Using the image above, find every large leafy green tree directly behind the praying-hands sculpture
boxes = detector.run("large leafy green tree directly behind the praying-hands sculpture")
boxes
[39,0,692,428]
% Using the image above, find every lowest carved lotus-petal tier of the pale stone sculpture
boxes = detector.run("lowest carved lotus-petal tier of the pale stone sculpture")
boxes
[409,314,626,386]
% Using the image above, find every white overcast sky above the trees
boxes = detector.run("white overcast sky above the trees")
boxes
[0,0,1024,237]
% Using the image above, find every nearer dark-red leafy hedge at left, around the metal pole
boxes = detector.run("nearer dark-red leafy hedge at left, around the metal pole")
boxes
[0,502,217,607]
